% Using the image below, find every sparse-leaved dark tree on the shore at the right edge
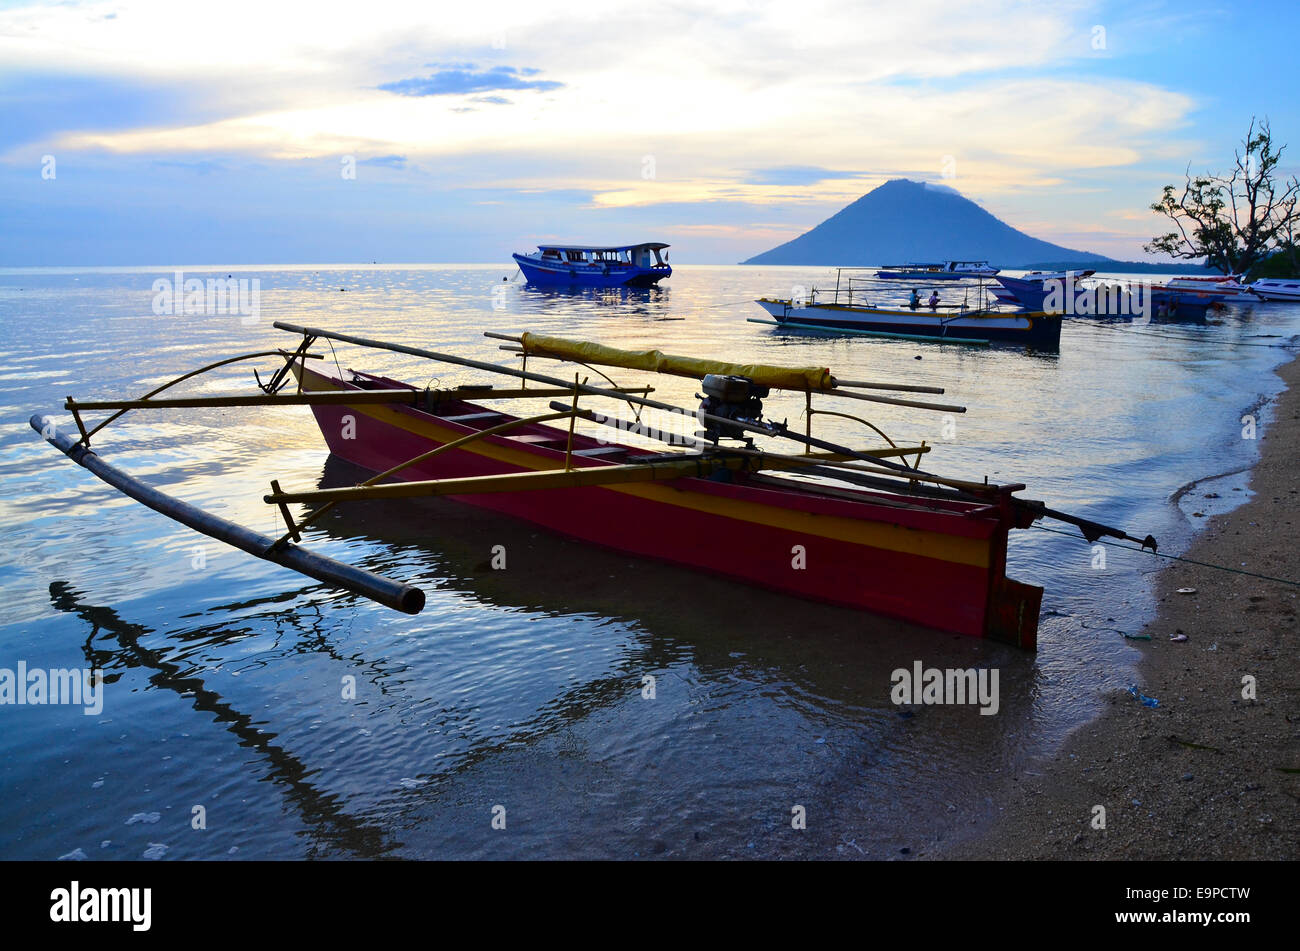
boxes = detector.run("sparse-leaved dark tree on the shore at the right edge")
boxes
[1144,118,1300,274]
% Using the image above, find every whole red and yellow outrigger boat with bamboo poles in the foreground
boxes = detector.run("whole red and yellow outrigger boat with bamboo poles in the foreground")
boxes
[31,322,1156,650]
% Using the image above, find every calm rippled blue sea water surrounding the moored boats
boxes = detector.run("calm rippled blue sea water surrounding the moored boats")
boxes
[0,265,1300,859]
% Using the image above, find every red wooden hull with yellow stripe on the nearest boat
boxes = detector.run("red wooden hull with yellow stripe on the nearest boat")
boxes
[302,370,1043,648]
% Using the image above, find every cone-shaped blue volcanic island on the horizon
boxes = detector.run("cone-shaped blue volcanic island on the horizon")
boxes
[741,178,1205,273]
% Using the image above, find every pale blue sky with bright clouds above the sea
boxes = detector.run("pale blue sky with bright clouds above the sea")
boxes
[0,0,1300,266]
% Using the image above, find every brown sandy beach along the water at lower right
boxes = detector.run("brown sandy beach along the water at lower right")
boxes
[946,348,1300,860]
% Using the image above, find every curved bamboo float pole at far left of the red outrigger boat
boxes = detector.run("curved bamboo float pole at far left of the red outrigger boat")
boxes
[30,414,424,615]
